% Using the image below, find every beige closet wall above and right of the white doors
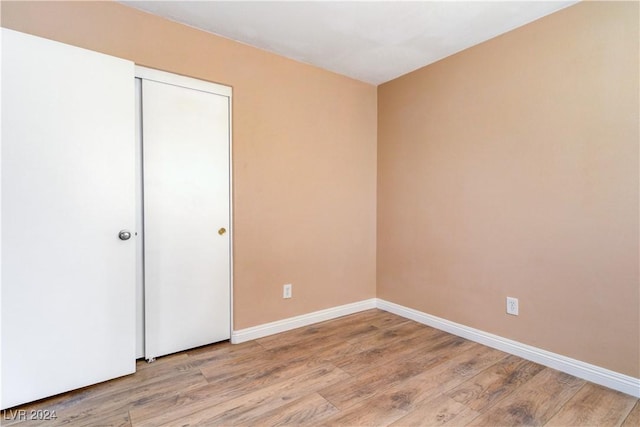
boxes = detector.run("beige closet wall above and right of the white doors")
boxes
[2,1,376,329]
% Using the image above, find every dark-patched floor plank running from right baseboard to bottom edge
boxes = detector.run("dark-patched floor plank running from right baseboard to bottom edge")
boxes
[470,368,585,426]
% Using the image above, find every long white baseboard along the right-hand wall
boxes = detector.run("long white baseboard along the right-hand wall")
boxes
[376,298,640,398]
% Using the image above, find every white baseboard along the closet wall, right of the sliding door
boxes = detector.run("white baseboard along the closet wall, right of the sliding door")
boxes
[231,298,376,344]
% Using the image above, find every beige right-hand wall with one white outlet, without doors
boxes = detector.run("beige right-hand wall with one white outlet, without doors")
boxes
[377,2,640,377]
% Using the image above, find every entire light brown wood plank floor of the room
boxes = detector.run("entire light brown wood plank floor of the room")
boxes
[2,310,640,427]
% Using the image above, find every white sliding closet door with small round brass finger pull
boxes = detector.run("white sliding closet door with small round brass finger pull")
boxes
[142,73,231,359]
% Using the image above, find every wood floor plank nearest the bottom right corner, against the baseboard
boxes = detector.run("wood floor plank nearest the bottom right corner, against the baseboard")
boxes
[546,383,637,426]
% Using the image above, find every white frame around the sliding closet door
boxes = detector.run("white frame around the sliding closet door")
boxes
[135,65,234,358]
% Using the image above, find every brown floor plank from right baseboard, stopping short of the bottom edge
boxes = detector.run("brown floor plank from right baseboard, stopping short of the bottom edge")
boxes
[447,355,544,412]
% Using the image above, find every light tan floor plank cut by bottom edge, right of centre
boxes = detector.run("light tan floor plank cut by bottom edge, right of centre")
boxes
[384,395,479,427]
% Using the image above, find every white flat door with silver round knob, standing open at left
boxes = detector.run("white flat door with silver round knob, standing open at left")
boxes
[1,28,135,408]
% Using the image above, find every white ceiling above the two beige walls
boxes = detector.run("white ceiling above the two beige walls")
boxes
[120,0,577,85]
